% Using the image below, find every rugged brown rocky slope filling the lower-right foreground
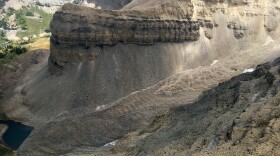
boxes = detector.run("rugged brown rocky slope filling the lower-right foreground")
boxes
[88,54,280,155]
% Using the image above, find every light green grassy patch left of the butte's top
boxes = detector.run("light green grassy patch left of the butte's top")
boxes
[15,6,52,37]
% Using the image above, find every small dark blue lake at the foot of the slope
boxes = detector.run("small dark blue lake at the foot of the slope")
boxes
[0,120,33,150]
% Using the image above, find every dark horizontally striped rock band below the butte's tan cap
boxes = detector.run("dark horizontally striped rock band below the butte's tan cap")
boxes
[52,17,199,47]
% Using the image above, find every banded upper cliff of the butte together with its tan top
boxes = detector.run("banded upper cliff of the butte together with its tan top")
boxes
[51,3,199,47]
